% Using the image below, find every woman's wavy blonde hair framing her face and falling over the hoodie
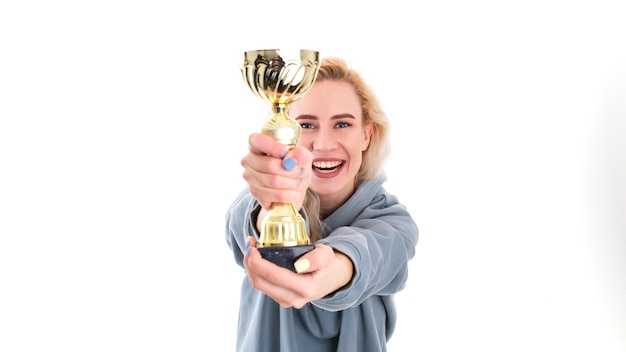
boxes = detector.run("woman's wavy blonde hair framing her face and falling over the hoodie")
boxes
[303,57,390,242]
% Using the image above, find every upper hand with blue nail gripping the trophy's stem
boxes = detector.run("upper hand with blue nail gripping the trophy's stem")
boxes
[241,133,313,213]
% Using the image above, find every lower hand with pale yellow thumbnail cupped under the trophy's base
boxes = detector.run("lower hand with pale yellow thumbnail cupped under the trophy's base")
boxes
[243,237,354,309]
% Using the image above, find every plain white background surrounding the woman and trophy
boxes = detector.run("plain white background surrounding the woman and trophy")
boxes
[0,0,626,352]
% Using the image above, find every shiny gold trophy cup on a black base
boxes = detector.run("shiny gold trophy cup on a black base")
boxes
[241,49,320,271]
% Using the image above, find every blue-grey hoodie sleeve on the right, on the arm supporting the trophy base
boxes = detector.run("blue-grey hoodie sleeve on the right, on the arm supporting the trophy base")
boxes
[313,193,418,311]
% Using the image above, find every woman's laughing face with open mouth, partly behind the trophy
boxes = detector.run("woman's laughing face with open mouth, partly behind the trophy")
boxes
[289,80,372,212]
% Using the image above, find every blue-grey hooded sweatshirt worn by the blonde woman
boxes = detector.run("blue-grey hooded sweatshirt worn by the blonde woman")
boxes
[226,175,418,352]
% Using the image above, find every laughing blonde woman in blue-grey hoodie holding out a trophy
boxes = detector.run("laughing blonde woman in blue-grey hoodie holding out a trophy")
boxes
[226,58,418,352]
